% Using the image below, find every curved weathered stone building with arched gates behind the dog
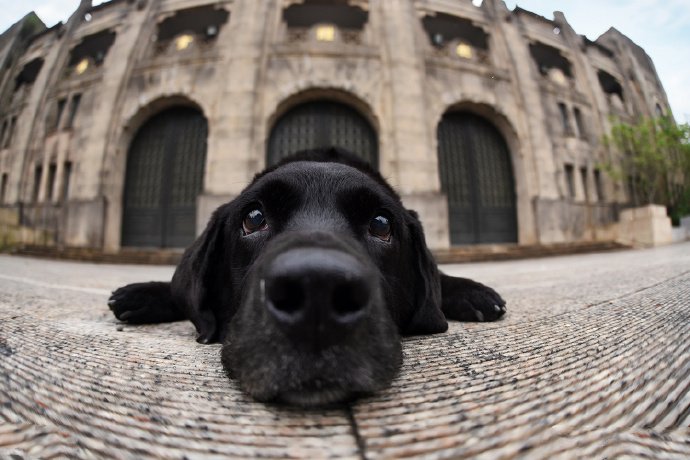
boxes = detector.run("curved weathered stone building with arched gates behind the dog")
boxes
[0,0,669,252]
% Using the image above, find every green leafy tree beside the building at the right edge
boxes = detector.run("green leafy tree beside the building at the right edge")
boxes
[603,116,690,222]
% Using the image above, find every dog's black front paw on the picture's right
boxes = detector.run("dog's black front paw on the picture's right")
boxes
[442,277,506,321]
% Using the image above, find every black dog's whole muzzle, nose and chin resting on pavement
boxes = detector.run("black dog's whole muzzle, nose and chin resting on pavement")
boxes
[222,233,402,406]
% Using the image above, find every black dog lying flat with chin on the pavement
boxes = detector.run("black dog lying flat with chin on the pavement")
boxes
[108,149,505,405]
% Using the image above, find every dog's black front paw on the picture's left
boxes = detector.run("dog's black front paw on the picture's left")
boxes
[108,282,183,324]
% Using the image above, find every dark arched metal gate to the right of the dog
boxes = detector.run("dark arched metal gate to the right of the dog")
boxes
[438,112,517,245]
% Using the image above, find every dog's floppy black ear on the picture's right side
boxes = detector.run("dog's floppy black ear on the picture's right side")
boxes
[403,210,448,335]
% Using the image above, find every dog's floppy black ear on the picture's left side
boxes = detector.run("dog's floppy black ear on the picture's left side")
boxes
[171,203,232,343]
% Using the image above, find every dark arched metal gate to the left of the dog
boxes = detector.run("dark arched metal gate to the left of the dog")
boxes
[122,107,208,248]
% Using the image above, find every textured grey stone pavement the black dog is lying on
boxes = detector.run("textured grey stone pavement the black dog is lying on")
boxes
[0,243,690,459]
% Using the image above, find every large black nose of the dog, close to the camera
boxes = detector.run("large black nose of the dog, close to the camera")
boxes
[262,248,374,346]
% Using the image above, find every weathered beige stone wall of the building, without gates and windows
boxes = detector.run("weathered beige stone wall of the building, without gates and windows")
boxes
[0,0,670,253]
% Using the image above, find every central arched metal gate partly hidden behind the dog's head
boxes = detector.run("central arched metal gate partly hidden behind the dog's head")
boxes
[266,101,378,168]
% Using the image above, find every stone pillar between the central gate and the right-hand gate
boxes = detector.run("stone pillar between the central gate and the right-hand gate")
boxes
[380,0,450,249]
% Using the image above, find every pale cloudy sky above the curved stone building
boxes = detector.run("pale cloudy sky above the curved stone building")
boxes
[0,0,690,123]
